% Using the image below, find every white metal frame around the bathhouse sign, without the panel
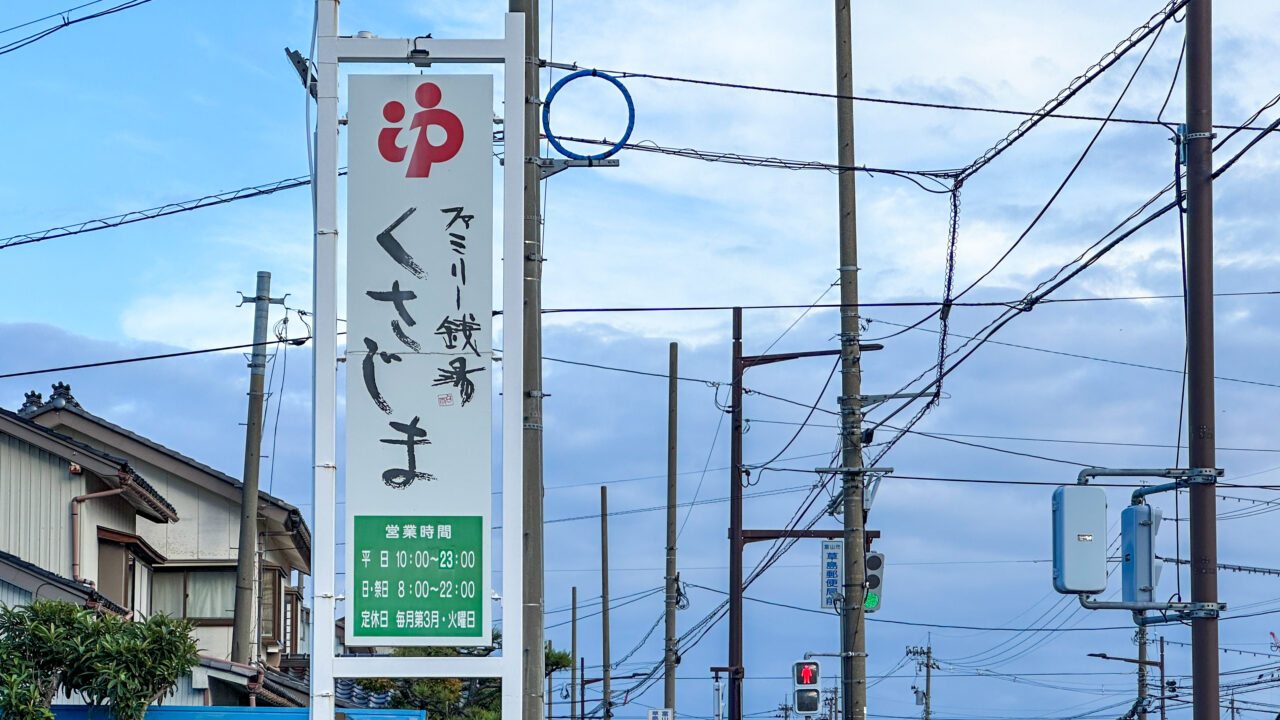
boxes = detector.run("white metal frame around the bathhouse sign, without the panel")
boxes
[310,0,531,720]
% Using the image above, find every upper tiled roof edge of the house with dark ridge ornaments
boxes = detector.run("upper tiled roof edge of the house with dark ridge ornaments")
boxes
[19,383,311,568]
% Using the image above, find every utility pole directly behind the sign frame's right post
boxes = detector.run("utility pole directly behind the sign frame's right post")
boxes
[504,0,547,720]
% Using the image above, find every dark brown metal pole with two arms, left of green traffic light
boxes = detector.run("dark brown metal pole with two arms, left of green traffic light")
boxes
[728,307,744,720]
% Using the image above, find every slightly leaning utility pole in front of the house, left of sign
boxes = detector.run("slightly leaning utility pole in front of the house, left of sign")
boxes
[232,270,284,665]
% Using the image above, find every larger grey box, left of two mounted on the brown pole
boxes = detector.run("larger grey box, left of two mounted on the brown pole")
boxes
[1053,486,1107,594]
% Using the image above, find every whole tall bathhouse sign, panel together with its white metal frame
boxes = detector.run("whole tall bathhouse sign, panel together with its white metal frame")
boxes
[311,0,530,707]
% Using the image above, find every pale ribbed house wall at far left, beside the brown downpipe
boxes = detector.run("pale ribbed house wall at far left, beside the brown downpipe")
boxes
[0,434,79,578]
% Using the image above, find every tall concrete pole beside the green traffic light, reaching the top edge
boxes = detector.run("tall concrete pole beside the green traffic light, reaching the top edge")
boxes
[836,0,870,720]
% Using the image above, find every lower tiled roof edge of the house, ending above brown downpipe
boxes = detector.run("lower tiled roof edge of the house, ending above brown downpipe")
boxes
[0,407,178,523]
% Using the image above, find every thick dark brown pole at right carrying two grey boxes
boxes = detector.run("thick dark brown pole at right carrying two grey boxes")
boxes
[1183,0,1220,720]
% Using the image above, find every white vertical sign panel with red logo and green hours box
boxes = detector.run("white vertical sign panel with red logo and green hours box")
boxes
[346,74,494,647]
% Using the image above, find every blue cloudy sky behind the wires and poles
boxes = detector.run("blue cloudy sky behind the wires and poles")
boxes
[0,0,1280,719]
